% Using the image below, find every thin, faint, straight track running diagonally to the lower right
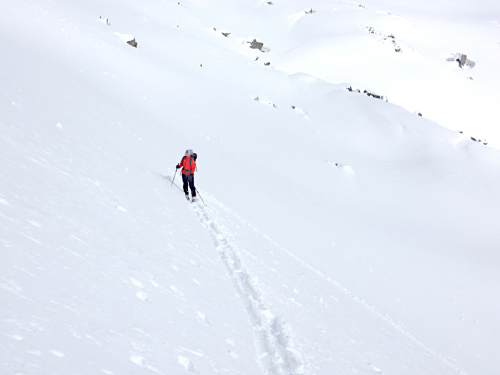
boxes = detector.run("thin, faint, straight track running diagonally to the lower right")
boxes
[201,193,467,375]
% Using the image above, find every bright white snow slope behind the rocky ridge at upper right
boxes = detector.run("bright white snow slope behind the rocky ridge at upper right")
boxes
[272,1,500,147]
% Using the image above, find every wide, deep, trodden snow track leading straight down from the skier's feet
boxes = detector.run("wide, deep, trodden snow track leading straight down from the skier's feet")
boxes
[193,203,306,375]
